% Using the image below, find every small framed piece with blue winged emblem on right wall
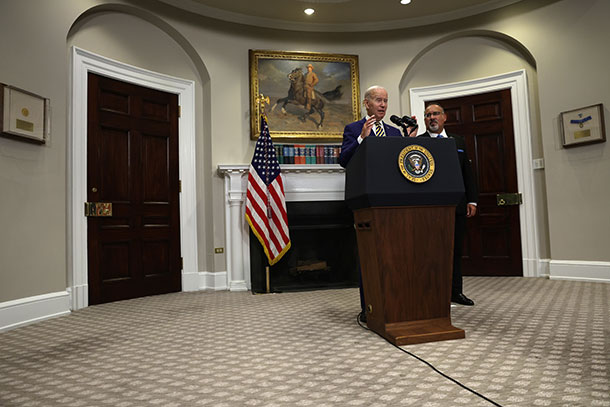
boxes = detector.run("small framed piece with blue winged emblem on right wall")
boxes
[560,103,606,148]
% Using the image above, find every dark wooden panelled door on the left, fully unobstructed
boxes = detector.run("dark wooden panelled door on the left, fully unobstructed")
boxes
[87,74,182,304]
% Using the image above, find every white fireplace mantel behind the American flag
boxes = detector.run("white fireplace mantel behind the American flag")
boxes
[218,164,345,291]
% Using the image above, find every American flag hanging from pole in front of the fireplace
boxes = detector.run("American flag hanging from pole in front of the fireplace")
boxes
[246,117,290,265]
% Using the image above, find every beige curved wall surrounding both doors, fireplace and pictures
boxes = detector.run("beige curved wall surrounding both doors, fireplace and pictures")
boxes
[0,0,610,302]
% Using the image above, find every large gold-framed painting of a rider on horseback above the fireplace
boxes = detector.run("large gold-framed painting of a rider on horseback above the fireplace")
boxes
[249,50,360,142]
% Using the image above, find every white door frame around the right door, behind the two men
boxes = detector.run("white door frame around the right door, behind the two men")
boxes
[409,70,544,277]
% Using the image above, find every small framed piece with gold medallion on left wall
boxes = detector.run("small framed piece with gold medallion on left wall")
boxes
[0,83,50,144]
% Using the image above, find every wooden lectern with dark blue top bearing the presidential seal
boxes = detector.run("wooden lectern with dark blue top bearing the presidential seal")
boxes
[345,137,465,346]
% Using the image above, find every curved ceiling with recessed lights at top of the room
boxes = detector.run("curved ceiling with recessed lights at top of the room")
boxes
[161,0,522,32]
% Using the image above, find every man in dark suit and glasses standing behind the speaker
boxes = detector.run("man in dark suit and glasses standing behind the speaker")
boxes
[417,104,479,305]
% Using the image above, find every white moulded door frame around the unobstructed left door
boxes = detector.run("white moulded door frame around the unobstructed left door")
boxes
[67,47,199,309]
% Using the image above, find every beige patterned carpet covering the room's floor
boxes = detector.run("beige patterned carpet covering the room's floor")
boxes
[0,277,610,407]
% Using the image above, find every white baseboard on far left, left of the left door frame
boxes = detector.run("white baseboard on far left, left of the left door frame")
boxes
[0,291,70,332]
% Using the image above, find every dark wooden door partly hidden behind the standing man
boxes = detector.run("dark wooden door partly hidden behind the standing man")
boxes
[427,89,523,276]
